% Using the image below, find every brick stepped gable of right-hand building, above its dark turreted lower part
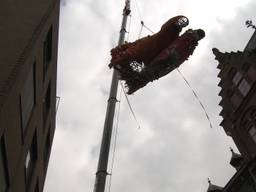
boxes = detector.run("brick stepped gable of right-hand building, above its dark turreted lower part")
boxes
[213,30,256,160]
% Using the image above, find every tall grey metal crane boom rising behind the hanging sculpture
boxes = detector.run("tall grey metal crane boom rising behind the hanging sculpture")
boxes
[93,0,130,192]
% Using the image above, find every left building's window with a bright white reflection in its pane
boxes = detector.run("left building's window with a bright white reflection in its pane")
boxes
[25,132,37,184]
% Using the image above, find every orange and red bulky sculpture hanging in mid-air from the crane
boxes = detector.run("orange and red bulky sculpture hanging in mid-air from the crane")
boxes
[109,16,205,94]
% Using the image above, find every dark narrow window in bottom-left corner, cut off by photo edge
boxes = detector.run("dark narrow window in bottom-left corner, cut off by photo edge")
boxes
[0,138,8,192]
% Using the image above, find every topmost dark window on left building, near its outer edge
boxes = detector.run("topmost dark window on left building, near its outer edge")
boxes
[43,27,52,78]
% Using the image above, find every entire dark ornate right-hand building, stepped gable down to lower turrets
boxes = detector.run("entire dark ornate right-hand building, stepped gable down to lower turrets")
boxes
[208,29,256,192]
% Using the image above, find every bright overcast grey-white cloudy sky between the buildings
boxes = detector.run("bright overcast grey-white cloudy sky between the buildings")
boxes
[45,0,256,192]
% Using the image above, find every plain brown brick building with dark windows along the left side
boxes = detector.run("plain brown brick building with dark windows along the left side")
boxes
[0,0,59,192]
